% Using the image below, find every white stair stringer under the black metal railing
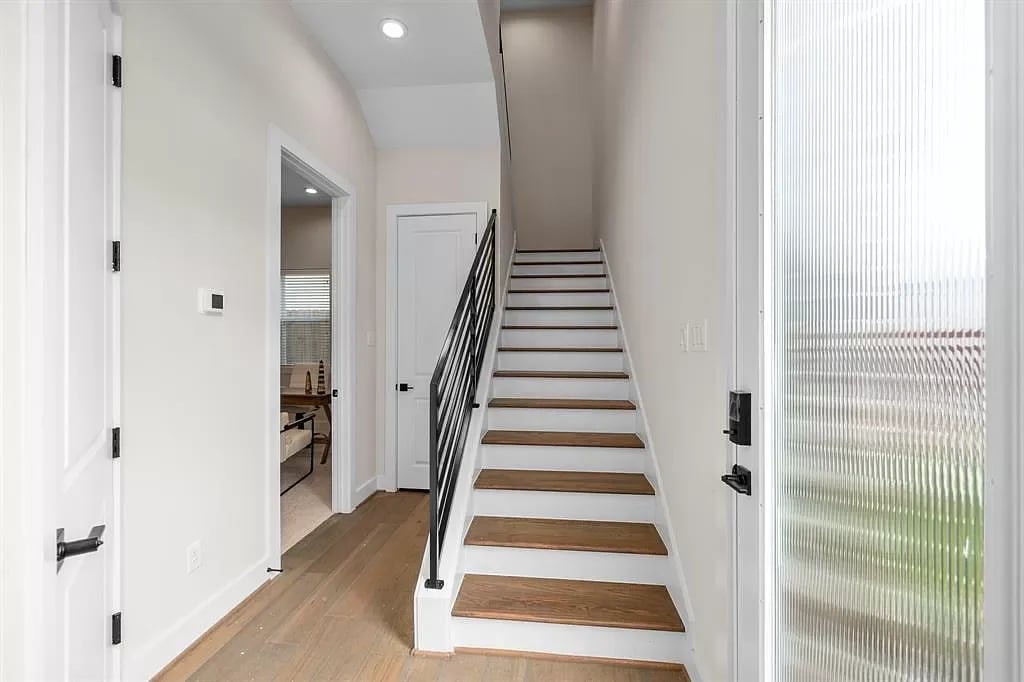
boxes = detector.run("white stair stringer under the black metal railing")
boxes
[413,235,516,653]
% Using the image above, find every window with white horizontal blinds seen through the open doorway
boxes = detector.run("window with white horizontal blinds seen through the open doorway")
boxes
[281,272,331,365]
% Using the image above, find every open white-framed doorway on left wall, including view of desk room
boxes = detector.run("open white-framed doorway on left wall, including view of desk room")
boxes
[266,128,355,569]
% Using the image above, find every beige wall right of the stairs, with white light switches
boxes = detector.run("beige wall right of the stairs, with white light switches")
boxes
[589,0,732,681]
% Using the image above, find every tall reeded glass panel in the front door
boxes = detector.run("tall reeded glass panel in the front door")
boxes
[769,0,985,682]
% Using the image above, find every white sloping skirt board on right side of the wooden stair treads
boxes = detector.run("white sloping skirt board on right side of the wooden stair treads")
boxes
[598,240,706,682]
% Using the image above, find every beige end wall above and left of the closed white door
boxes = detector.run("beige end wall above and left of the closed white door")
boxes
[377,145,501,486]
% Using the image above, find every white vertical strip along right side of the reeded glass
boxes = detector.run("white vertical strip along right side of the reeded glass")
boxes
[985,0,1024,680]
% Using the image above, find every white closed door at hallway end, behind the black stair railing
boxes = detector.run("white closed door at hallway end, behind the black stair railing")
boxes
[396,212,480,489]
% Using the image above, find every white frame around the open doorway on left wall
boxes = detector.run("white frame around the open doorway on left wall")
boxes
[263,125,358,567]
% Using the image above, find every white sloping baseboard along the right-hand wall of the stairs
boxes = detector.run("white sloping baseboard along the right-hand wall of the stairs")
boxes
[598,240,707,682]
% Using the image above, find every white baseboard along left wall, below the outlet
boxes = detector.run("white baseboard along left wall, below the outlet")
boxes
[122,557,273,680]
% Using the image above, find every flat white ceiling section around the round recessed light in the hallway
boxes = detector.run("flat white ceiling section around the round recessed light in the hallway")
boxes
[291,0,494,90]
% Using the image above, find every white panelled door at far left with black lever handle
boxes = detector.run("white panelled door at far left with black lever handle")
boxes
[51,0,120,680]
